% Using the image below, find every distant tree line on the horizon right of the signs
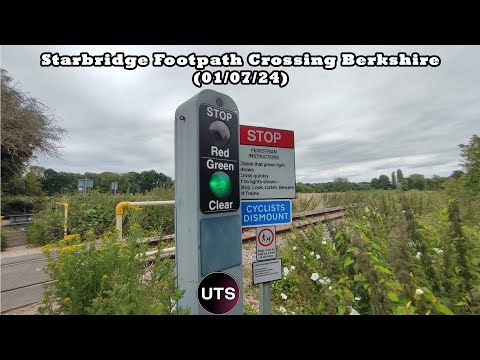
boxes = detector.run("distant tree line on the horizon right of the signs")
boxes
[297,169,465,193]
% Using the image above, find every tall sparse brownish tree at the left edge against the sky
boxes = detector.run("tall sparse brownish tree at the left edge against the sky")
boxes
[0,69,66,181]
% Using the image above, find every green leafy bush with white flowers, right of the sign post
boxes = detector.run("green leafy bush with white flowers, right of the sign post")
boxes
[272,190,480,314]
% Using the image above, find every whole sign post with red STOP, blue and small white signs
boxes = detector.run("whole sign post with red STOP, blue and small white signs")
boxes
[240,125,296,315]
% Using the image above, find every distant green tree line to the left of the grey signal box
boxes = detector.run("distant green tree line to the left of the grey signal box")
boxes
[2,166,173,196]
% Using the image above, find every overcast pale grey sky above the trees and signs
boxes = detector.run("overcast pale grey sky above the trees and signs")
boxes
[1,45,480,182]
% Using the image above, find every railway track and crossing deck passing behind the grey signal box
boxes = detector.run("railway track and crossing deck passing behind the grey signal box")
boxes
[1,207,345,314]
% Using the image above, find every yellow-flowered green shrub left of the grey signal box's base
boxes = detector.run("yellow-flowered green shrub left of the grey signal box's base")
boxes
[39,227,185,315]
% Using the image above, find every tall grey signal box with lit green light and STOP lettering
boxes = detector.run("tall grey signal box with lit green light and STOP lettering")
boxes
[175,90,243,315]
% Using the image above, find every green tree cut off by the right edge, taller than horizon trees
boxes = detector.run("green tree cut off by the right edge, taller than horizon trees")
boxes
[458,134,480,195]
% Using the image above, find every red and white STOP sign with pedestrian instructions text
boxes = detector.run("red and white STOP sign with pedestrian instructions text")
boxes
[239,125,295,200]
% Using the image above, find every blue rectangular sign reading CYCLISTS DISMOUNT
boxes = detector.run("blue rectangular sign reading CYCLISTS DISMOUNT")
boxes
[242,200,292,227]
